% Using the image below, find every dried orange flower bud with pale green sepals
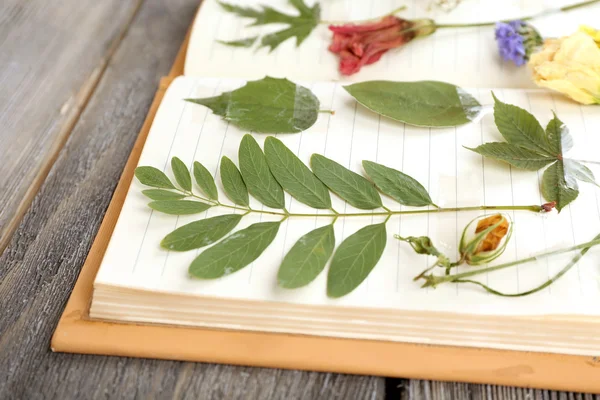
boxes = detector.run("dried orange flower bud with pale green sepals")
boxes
[459,214,512,265]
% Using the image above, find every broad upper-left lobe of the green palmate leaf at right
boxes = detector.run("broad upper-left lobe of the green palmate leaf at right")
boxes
[492,93,553,155]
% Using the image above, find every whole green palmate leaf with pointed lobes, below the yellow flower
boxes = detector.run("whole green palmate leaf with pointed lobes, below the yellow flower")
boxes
[469,96,596,212]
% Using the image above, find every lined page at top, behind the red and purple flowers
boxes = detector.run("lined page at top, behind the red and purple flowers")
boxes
[185,0,600,88]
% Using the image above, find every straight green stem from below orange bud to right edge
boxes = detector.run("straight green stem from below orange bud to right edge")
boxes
[423,236,600,290]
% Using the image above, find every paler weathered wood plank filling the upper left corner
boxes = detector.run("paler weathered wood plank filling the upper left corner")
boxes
[0,0,141,252]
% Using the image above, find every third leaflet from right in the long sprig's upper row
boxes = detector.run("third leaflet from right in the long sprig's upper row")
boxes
[265,136,331,209]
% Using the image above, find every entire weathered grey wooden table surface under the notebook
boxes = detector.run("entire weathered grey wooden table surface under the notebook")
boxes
[0,0,600,400]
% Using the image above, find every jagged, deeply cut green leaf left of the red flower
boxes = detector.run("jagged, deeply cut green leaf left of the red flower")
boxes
[219,0,321,51]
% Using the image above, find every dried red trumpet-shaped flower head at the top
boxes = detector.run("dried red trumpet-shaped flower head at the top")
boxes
[329,15,418,75]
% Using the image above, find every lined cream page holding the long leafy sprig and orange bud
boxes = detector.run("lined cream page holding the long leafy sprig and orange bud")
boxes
[96,77,600,315]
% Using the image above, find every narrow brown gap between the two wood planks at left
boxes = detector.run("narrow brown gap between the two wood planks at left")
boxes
[0,0,144,255]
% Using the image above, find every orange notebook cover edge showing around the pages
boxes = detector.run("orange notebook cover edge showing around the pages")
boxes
[51,15,600,392]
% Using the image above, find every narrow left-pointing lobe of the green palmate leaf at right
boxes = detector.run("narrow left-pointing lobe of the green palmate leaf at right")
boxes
[467,142,556,171]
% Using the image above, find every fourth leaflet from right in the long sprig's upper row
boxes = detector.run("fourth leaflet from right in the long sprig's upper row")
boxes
[238,135,285,208]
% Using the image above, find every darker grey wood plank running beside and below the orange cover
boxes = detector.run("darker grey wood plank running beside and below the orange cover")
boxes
[0,0,384,399]
